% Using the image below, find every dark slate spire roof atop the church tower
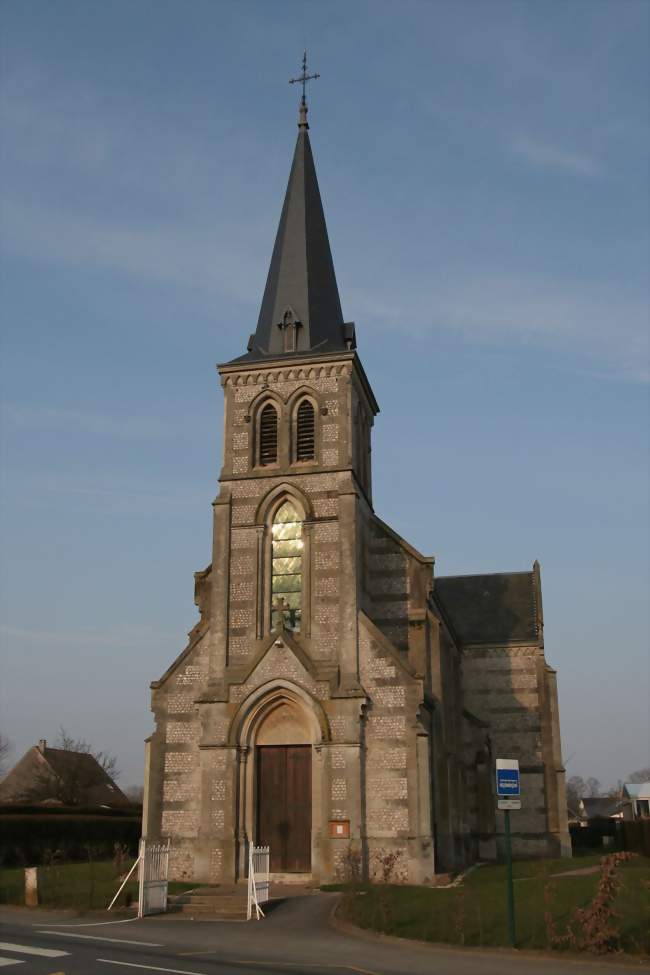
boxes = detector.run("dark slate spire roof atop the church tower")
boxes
[235,100,354,362]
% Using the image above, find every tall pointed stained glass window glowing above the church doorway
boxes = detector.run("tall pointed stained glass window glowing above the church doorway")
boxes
[271,501,303,633]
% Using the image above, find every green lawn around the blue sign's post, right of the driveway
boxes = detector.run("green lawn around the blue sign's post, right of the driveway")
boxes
[340,856,650,954]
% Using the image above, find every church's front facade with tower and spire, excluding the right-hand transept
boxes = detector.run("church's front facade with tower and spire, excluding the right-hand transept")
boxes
[145,60,464,883]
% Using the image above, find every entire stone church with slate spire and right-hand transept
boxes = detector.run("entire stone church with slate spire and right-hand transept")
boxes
[143,82,570,884]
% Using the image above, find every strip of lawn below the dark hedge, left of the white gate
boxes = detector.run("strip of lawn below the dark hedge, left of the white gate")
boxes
[0,860,196,911]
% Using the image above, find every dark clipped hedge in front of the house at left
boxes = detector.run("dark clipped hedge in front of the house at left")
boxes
[0,807,142,867]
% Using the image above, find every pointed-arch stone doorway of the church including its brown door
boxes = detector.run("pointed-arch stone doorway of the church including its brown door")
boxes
[230,681,327,876]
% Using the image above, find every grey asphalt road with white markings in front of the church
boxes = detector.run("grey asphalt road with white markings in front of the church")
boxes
[0,893,650,975]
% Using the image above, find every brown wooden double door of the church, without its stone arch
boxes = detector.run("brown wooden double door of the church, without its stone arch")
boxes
[257,745,311,873]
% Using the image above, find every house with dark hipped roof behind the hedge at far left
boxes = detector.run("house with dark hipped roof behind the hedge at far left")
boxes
[0,738,131,807]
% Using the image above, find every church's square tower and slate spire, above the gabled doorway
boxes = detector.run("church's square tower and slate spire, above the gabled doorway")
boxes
[212,70,378,691]
